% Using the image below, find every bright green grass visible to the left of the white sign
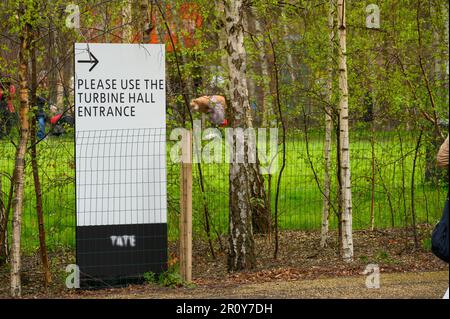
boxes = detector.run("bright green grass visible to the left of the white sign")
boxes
[0,138,75,252]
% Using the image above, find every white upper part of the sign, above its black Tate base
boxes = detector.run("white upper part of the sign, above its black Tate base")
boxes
[74,43,167,226]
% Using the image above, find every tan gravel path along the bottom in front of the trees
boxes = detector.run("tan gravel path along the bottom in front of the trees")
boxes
[68,271,449,299]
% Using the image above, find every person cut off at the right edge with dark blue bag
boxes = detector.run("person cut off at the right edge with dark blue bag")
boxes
[432,136,449,299]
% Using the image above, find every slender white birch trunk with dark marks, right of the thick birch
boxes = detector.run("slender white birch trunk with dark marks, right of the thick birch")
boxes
[337,0,353,261]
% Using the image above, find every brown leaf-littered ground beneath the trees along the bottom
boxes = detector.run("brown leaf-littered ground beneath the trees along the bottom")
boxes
[0,226,448,298]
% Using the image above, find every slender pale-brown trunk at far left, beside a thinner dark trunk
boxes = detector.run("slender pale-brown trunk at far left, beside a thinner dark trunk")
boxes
[11,20,31,297]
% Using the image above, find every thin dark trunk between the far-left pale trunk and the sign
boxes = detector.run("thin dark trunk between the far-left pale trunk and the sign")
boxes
[30,38,52,287]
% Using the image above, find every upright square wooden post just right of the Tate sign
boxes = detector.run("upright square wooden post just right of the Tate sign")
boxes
[180,131,192,282]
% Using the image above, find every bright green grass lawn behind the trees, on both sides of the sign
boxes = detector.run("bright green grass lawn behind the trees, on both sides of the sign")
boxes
[0,132,446,252]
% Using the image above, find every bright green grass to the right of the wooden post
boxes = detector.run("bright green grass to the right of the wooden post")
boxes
[187,133,446,238]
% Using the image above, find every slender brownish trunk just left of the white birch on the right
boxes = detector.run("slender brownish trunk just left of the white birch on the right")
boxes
[320,0,335,247]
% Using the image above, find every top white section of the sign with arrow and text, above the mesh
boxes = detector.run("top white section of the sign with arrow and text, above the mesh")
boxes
[74,43,166,131]
